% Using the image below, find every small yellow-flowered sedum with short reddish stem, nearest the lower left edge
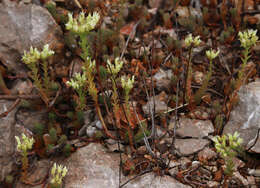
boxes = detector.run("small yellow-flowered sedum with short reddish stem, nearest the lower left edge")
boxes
[15,134,34,178]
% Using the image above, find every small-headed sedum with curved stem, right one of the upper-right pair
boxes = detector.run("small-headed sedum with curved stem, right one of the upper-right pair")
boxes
[194,49,219,104]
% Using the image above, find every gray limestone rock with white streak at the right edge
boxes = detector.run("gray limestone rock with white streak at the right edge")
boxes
[223,81,260,153]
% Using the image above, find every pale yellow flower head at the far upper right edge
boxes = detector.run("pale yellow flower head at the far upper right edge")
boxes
[238,29,258,49]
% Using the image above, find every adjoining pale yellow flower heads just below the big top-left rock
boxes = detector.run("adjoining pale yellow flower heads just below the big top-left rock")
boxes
[22,44,54,65]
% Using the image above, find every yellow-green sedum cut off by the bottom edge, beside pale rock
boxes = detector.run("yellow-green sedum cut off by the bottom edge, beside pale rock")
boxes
[50,163,68,188]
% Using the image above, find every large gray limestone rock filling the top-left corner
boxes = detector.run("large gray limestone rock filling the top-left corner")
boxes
[0,0,63,75]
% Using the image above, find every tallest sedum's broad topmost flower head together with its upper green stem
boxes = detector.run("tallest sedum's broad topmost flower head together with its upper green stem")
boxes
[66,12,100,61]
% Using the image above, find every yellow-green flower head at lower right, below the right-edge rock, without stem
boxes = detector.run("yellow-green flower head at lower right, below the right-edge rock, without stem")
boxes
[213,132,243,158]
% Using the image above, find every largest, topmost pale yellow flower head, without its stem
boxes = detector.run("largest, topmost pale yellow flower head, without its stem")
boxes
[66,12,100,34]
